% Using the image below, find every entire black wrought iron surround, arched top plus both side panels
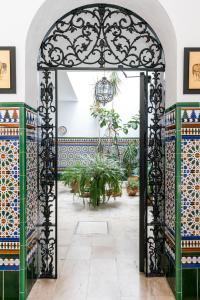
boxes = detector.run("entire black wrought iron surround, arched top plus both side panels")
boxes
[38,4,165,278]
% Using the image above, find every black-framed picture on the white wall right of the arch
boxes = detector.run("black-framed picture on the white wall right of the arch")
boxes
[183,48,200,94]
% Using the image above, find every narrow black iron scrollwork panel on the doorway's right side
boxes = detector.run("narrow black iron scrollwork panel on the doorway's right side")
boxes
[146,72,165,276]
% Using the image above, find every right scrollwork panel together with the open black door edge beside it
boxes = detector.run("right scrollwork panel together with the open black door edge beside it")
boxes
[140,72,165,276]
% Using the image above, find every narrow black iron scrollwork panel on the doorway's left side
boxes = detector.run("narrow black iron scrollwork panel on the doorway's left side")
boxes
[38,71,57,278]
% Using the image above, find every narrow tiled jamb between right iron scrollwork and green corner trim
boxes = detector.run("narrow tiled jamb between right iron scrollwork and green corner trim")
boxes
[165,110,175,261]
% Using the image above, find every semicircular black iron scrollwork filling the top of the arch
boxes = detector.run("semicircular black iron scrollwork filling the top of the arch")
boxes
[38,4,165,71]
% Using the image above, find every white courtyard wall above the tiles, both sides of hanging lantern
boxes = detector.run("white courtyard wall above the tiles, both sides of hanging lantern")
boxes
[58,71,140,137]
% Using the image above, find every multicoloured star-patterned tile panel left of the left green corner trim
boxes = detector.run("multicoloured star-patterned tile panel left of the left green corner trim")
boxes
[0,108,20,271]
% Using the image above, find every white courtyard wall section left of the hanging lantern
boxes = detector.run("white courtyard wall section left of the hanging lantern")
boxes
[58,72,98,137]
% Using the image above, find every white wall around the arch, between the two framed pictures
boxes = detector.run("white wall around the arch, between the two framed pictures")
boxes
[0,0,200,106]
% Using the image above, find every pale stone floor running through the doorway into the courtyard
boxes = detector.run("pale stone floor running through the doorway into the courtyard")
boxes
[28,183,174,300]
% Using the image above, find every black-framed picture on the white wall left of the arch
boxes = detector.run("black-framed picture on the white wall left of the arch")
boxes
[0,47,16,94]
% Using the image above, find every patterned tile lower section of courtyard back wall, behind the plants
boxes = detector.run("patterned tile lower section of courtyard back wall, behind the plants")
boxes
[58,138,138,172]
